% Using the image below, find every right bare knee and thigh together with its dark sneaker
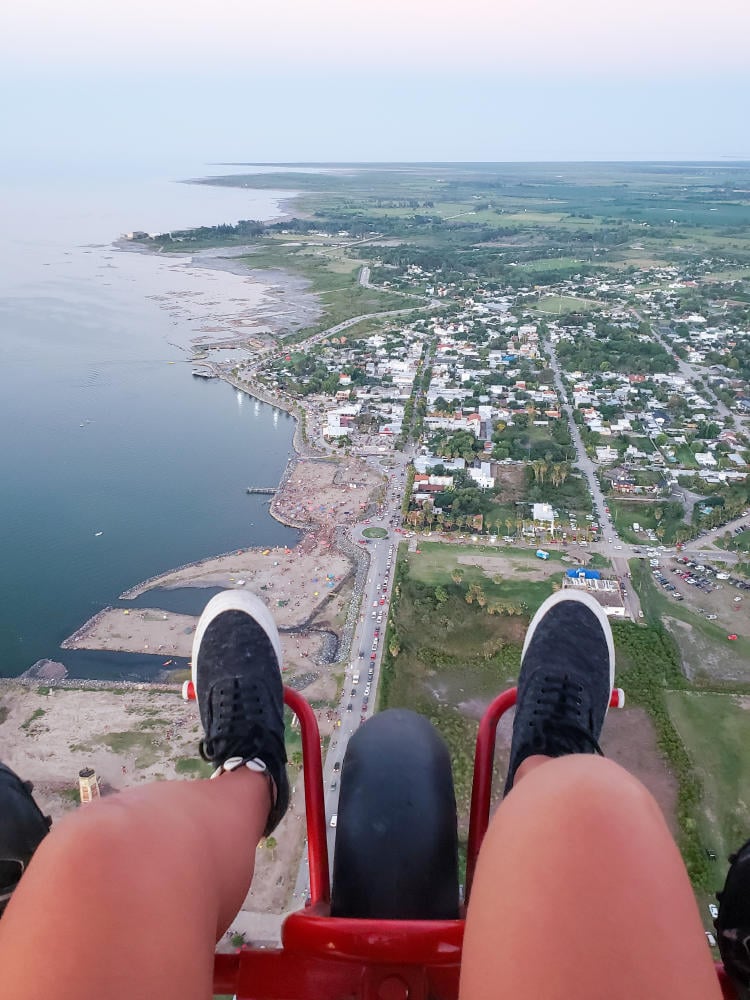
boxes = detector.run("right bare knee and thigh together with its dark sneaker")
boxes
[468,590,720,1000]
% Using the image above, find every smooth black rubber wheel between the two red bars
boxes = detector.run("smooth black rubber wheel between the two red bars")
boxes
[331,709,459,920]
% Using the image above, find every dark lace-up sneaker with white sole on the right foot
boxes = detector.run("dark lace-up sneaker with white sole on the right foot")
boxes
[505,590,615,795]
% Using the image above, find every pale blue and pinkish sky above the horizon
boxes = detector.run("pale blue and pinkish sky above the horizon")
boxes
[0,0,750,169]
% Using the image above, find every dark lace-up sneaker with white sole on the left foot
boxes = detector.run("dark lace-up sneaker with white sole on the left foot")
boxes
[193,590,289,837]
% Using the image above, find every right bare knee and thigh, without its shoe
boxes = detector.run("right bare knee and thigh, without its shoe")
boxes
[460,754,721,1000]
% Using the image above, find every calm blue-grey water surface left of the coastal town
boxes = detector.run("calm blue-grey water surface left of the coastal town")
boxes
[0,164,297,676]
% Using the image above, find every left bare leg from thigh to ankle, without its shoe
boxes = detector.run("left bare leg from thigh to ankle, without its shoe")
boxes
[0,768,270,1000]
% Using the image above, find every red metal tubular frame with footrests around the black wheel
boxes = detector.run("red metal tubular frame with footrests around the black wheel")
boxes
[214,688,736,1000]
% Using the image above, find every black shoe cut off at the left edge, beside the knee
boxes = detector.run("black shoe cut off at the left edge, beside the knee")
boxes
[0,764,52,916]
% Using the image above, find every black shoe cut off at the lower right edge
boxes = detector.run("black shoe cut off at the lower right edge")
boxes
[714,840,750,1000]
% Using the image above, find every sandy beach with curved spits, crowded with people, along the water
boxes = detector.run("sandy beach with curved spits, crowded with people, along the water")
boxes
[60,360,380,670]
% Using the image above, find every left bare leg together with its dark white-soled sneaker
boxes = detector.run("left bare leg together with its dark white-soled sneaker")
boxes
[0,591,289,1000]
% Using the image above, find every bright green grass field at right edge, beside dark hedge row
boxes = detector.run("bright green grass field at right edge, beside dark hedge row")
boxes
[666,691,750,886]
